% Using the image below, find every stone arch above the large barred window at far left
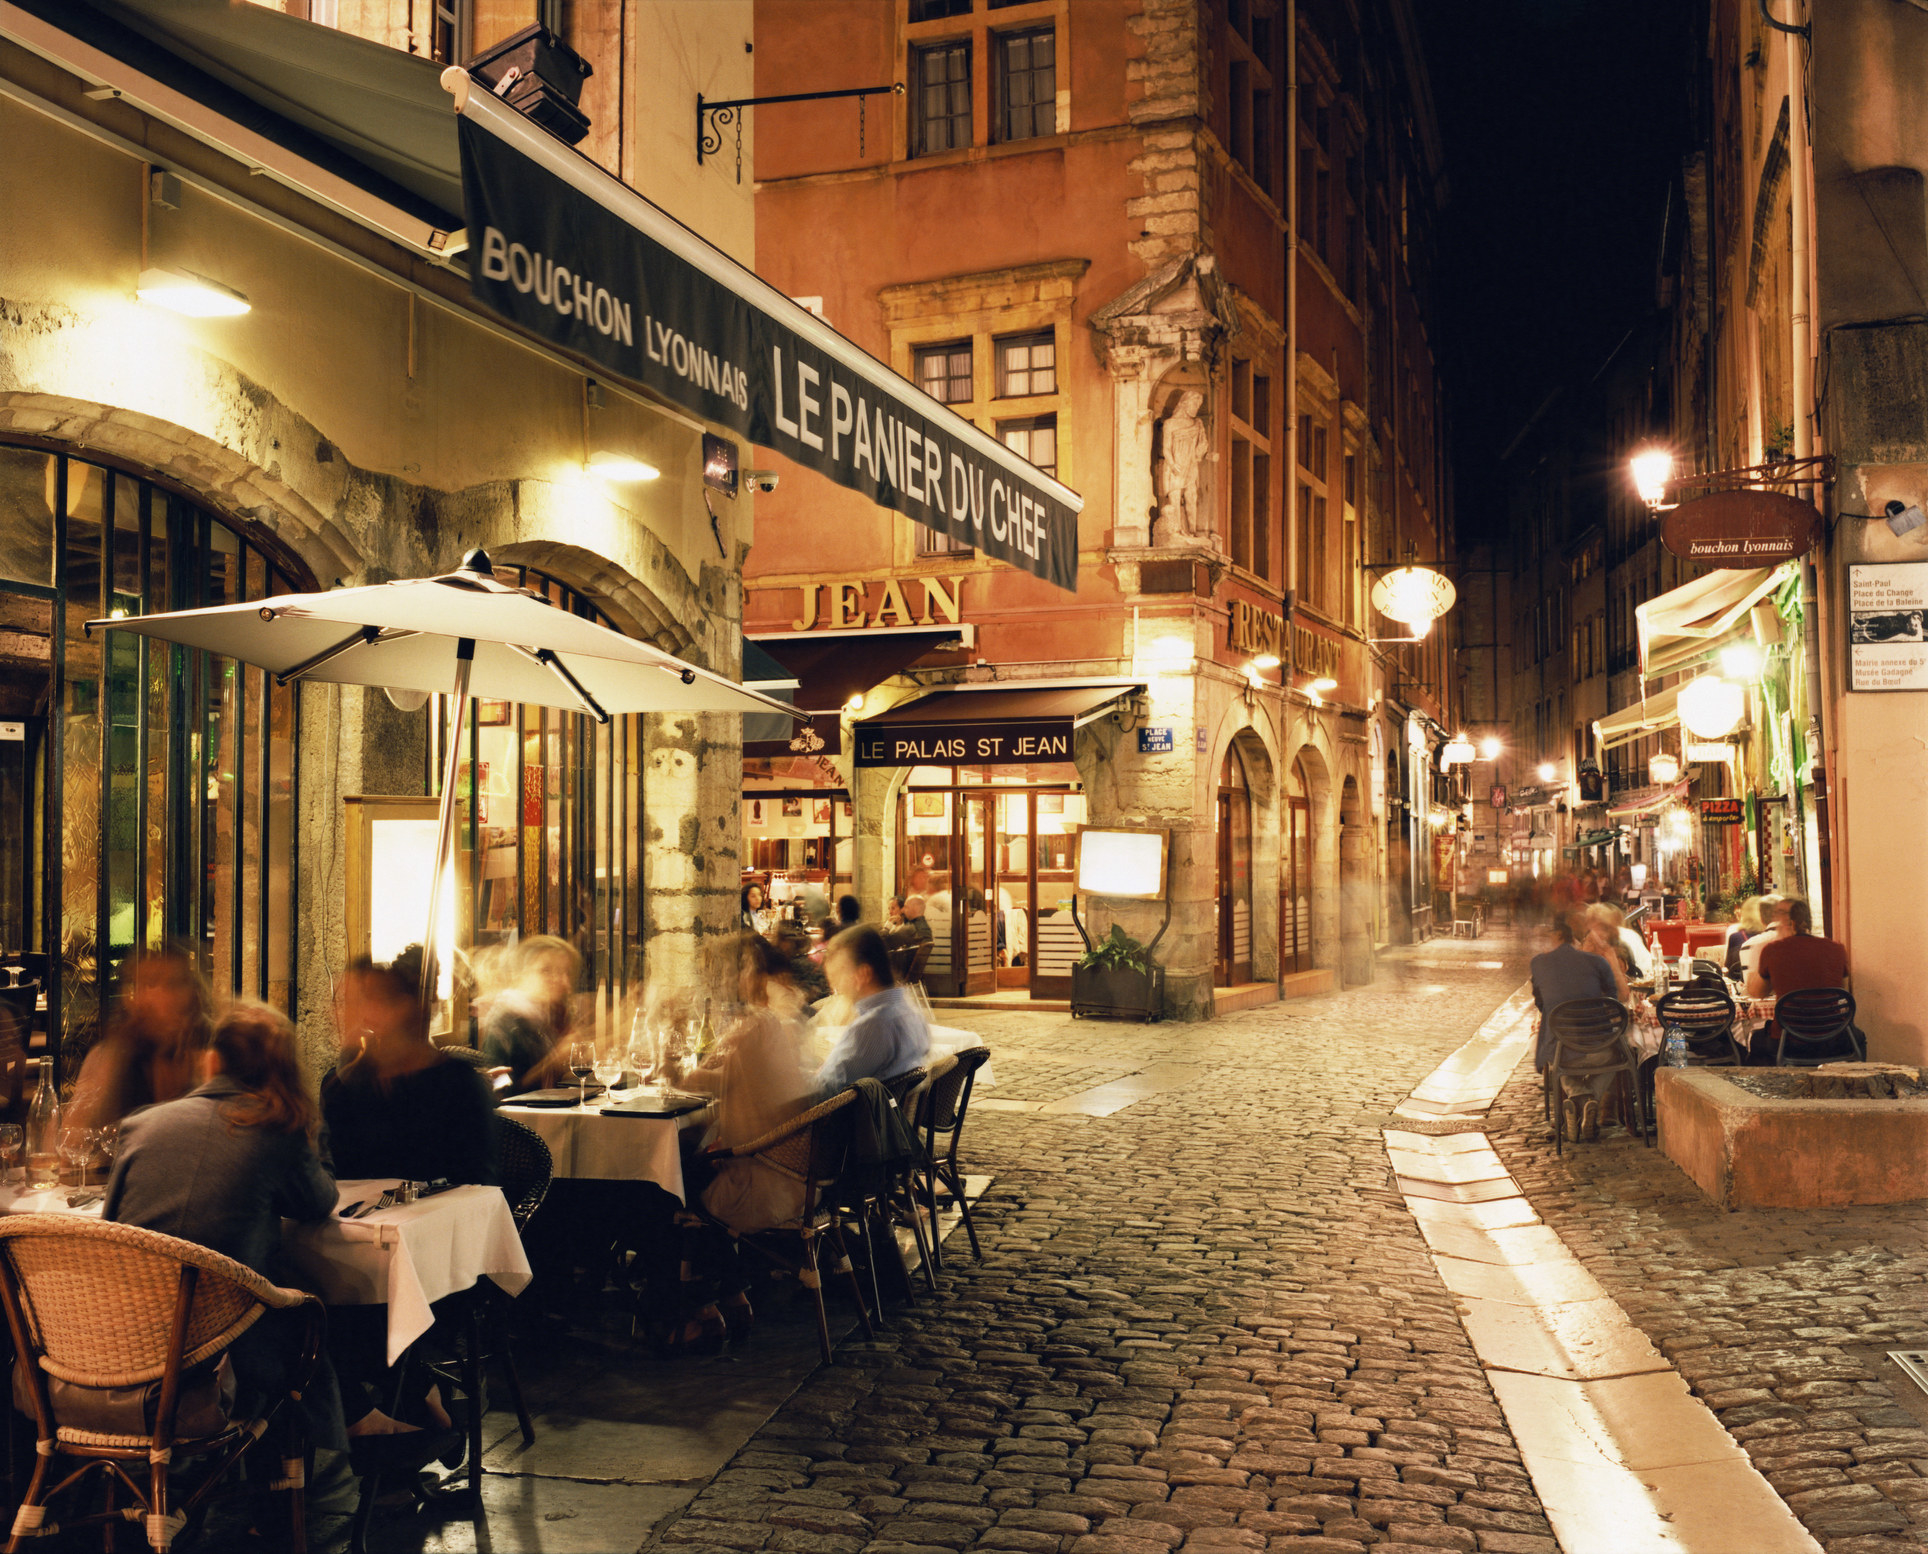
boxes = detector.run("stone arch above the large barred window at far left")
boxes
[0,391,362,588]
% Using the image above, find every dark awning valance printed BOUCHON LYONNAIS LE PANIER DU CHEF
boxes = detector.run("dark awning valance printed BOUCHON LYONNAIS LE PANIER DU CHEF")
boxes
[443,93,1084,590]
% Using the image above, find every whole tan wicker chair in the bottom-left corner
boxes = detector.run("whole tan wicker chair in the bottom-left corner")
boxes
[0,1215,324,1554]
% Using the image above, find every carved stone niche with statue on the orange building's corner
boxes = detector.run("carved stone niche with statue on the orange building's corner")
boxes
[1091,255,1242,578]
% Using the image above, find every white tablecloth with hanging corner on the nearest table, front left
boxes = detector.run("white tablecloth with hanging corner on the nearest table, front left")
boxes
[281,1180,530,1365]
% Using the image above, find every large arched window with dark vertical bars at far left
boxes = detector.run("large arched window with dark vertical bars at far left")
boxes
[0,445,302,1057]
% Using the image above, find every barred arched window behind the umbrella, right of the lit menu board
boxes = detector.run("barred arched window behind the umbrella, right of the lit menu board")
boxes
[428,567,646,1033]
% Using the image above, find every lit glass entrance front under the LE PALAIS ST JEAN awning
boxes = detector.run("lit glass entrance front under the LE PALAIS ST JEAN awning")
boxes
[895,762,1085,999]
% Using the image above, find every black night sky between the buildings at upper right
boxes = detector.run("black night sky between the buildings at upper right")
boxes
[1413,0,1704,542]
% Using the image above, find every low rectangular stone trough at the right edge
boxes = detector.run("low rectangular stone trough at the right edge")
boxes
[1654,1064,1928,1209]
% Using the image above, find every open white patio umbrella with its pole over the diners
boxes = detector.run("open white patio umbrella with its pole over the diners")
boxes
[85,549,796,1001]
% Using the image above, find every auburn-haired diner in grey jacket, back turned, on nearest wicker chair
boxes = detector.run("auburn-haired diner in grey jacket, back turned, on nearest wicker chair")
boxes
[100,1003,358,1452]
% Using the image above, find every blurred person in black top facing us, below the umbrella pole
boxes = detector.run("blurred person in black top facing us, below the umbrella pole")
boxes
[322,945,495,1182]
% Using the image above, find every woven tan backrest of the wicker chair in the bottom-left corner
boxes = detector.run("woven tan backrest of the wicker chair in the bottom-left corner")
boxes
[0,1215,271,1386]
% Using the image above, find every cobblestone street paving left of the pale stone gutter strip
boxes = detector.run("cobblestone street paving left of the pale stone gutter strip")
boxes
[657,933,1554,1554]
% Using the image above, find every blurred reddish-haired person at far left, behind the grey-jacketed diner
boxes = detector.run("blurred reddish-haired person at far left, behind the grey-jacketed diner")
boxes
[67,945,214,1128]
